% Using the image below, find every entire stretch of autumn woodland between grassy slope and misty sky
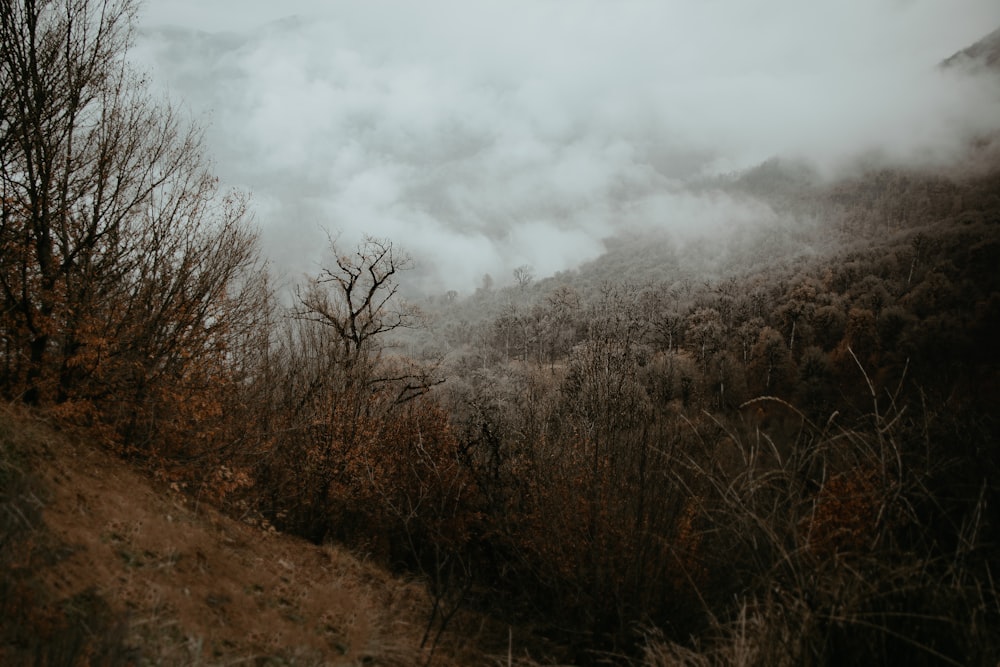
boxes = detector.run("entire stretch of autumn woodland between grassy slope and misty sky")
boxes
[0,0,1000,666]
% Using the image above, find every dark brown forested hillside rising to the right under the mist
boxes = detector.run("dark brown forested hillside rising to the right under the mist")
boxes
[406,157,1000,664]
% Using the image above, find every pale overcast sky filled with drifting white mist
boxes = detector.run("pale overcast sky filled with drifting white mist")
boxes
[133,0,1000,291]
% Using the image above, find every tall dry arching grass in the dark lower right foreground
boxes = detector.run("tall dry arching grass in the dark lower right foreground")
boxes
[644,360,1000,667]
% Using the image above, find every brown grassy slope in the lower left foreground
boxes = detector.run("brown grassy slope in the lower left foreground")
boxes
[0,408,484,665]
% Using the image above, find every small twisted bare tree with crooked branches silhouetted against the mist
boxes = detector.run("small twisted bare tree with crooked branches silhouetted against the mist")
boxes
[259,237,450,542]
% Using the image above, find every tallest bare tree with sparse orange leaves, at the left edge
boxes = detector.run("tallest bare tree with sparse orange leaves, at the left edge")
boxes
[0,0,260,438]
